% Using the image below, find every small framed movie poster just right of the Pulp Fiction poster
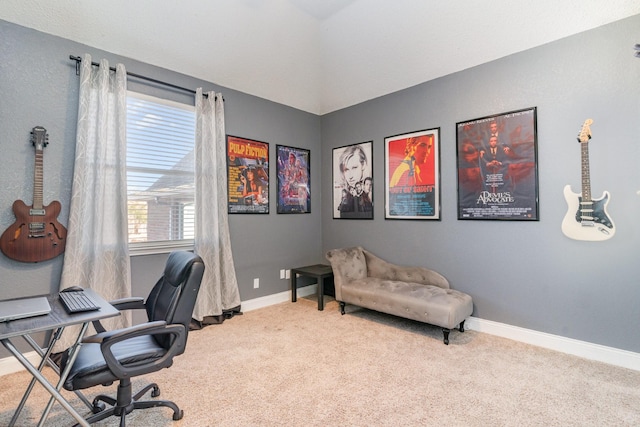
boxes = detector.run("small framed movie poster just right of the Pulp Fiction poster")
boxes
[276,145,311,213]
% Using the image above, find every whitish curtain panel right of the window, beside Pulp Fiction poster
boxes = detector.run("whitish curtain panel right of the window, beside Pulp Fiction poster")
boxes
[193,88,240,322]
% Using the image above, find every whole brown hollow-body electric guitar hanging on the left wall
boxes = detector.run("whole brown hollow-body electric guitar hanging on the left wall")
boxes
[0,126,67,262]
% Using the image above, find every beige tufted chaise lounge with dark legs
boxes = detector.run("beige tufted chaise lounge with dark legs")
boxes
[326,246,473,344]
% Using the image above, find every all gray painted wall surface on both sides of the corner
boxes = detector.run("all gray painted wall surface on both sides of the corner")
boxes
[0,16,640,356]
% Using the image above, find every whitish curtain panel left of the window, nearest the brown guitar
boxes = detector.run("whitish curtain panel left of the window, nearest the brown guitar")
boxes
[55,54,131,351]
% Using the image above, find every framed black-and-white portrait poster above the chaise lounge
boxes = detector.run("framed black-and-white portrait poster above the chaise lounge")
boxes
[332,141,373,219]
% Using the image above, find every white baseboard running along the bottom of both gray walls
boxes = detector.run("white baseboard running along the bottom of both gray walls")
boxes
[0,285,640,376]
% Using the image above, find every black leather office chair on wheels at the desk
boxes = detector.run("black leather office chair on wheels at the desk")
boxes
[61,252,204,427]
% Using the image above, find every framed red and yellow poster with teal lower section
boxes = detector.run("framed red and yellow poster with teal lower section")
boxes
[384,128,440,219]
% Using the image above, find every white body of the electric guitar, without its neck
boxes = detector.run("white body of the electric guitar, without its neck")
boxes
[562,185,616,242]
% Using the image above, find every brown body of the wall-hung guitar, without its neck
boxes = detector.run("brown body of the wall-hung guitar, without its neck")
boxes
[0,200,67,262]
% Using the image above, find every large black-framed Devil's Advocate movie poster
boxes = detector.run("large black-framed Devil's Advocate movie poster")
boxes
[456,107,539,221]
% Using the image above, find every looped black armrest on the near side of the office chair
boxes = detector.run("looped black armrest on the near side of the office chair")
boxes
[82,320,187,378]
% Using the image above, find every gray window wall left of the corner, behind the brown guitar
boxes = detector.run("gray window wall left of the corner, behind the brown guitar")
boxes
[0,20,323,356]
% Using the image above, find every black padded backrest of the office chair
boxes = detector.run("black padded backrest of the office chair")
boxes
[145,251,204,348]
